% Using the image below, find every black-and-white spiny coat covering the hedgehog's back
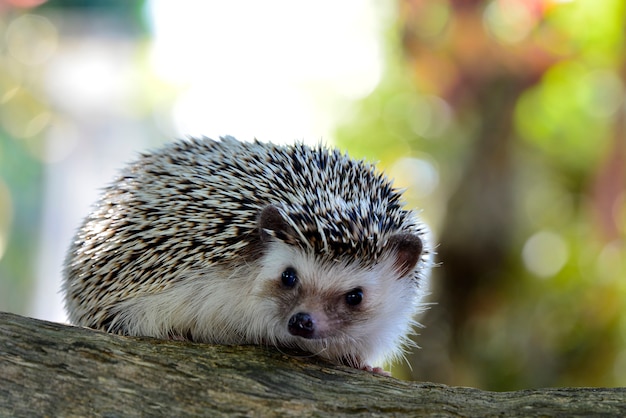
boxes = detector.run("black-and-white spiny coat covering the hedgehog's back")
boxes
[66,137,420,297]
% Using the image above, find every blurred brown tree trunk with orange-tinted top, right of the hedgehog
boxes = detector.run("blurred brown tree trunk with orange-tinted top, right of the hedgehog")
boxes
[400,0,555,384]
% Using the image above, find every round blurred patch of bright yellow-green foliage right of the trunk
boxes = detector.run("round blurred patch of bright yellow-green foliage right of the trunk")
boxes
[515,61,621,171]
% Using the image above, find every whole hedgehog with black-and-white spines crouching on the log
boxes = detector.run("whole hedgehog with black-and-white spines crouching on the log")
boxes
[63,136,431,373]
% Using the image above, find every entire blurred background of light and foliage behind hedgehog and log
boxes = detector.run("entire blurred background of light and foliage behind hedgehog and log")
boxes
[0,0,626,390]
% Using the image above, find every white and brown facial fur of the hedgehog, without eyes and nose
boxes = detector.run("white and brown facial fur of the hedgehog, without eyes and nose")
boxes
[253,242,425,366]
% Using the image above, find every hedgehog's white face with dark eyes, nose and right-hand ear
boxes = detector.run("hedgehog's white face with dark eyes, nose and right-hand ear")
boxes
[254,205,422,366]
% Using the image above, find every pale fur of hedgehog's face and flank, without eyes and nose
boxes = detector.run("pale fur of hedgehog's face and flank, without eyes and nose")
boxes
[113,238,426,367]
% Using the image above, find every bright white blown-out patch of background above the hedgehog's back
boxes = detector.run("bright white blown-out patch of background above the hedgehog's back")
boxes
[147,0,389,142]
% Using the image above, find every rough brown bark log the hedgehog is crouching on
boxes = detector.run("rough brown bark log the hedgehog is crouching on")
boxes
[0,313,626,417]
